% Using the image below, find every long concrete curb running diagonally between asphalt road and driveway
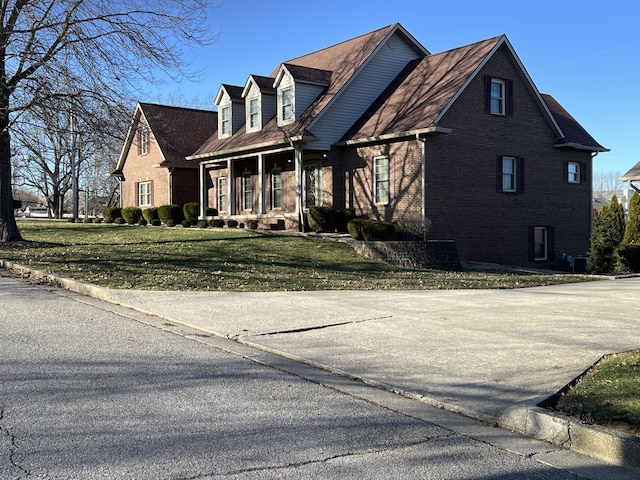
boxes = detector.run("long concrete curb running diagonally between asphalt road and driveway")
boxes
[0,259,640,469]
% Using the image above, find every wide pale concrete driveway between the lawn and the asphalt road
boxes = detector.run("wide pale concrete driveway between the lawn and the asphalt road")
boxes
[1,258,640,468]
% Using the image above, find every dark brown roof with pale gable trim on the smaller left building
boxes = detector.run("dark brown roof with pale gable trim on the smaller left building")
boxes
[112,102,218,175]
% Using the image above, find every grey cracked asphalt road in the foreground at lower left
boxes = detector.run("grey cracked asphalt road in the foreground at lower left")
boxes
[0,271,632,480]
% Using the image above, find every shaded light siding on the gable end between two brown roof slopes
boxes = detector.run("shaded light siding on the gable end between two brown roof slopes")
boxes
[308,32,422,150]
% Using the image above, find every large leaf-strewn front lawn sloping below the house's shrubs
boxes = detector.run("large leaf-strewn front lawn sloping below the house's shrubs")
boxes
[0,220,584,291]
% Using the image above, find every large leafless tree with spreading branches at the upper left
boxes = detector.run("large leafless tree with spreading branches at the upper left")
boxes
[0,0,214,241]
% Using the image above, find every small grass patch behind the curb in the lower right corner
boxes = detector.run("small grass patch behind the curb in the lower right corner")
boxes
[556,350,640,435]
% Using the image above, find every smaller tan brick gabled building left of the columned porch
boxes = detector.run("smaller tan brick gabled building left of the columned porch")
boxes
[111,103,218,208]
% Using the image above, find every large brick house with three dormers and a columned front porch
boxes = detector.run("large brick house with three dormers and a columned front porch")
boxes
[187,24,608,265]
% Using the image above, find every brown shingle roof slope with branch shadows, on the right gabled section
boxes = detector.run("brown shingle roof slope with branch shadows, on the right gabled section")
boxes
[343,37,502,140]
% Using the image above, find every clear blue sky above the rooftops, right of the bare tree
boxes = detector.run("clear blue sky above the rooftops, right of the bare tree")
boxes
[148,0,640,174]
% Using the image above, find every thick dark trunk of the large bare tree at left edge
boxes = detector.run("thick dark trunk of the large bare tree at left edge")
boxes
[0,104,22,242]
